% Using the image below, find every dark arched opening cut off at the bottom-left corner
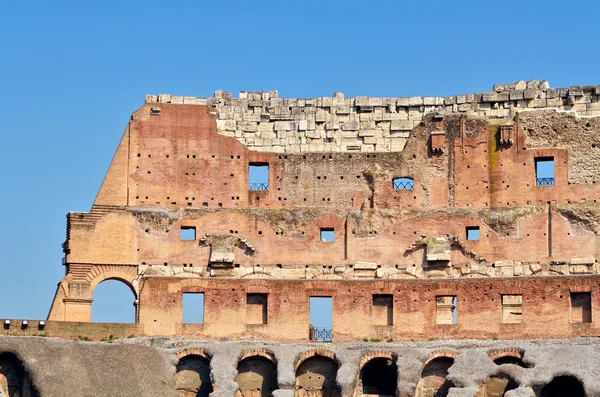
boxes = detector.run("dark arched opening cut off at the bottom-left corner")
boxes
[0,352,38,397]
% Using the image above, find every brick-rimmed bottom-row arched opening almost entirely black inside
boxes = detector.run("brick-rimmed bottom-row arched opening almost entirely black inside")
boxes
[360,357,398,396]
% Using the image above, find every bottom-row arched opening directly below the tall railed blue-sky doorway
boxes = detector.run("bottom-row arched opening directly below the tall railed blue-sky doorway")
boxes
[294,356,341,397]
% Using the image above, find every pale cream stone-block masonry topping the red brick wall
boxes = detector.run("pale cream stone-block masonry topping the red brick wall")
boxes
[146,80,600,153]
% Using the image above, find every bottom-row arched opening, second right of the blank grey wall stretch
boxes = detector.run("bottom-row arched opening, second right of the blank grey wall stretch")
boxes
[236,356,279,397]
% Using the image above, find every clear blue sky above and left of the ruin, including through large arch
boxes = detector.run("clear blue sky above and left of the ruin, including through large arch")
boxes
[0,0,600,320]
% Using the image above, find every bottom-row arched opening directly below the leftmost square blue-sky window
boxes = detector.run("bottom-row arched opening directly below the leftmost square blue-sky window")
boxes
[175,354,213,397]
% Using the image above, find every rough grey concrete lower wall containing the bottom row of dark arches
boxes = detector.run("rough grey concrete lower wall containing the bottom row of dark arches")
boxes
[0,337,600,397]
